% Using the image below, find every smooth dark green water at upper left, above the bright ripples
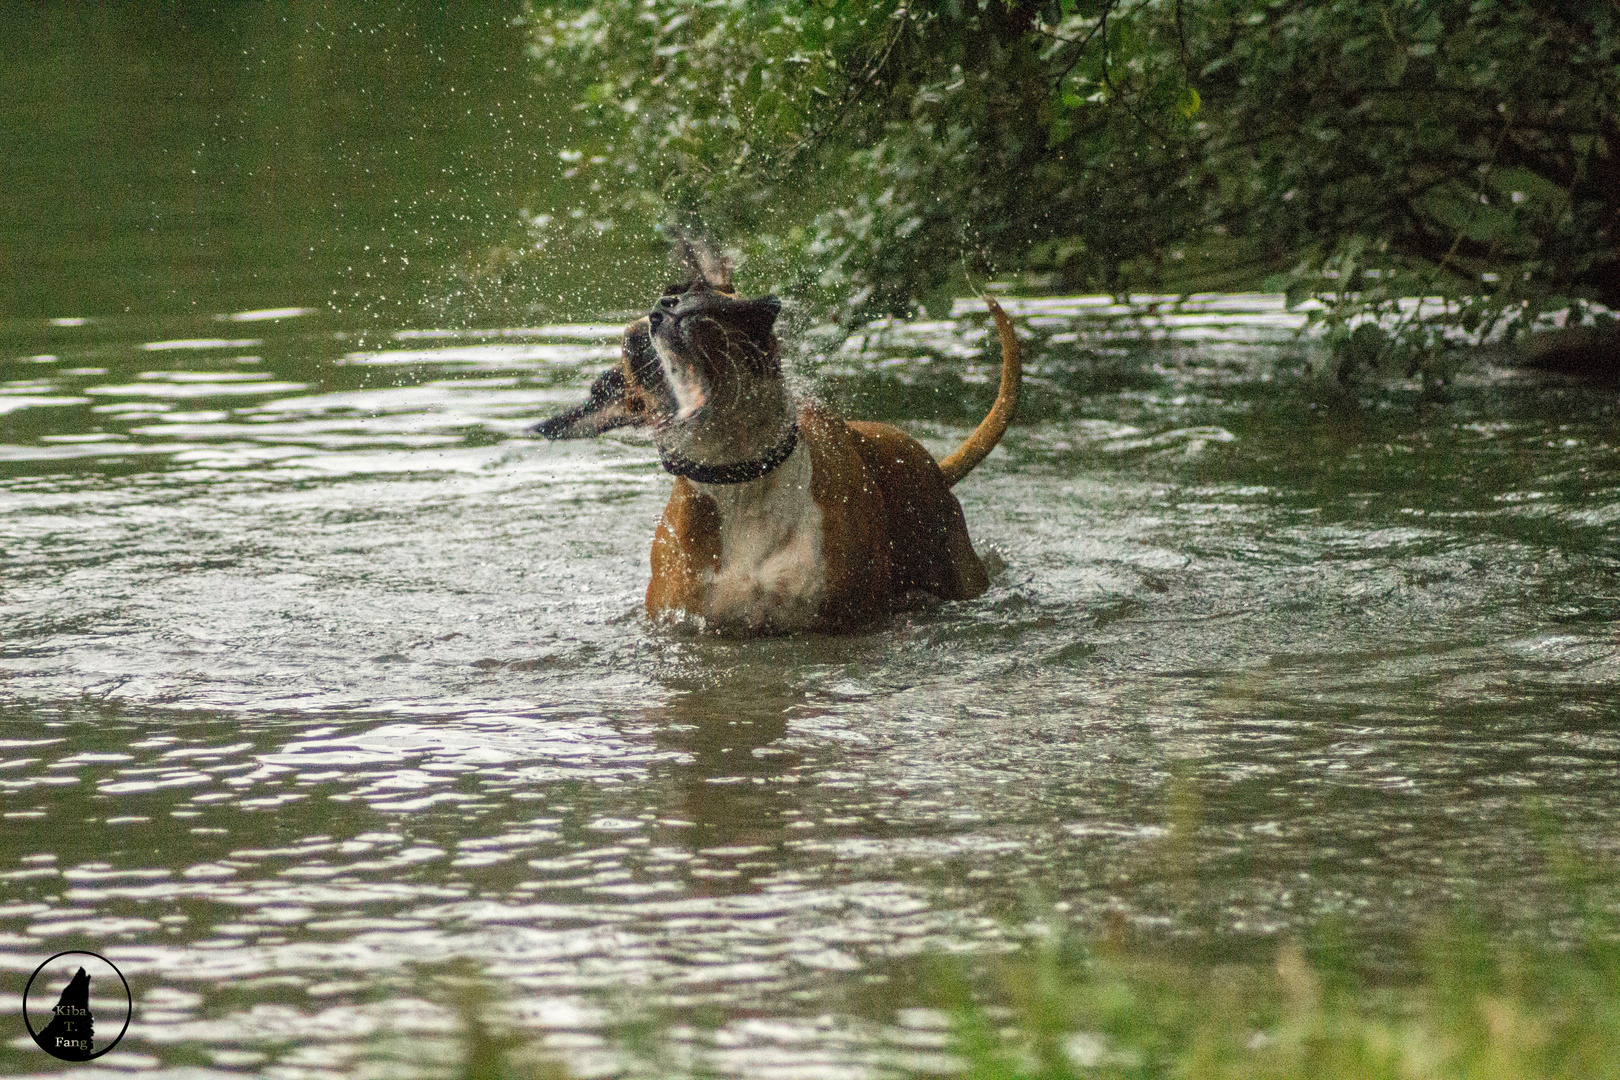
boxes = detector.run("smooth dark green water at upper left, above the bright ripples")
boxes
[0,3,567,324]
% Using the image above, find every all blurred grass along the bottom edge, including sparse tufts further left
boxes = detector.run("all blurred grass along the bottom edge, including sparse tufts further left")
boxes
[440,831,1620,1080]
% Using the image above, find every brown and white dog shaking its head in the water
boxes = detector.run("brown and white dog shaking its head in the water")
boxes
[535,248,1022,633]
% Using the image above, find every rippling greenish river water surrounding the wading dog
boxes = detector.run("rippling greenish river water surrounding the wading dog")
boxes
[0,8,1620,1077]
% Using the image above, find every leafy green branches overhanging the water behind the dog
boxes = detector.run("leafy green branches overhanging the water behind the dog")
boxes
[525,0,1620,379]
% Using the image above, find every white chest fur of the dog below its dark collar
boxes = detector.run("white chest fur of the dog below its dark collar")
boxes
[698,439,826,630]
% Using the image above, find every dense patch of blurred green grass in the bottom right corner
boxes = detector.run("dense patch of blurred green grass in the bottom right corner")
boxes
[933,923,1620,1080]
